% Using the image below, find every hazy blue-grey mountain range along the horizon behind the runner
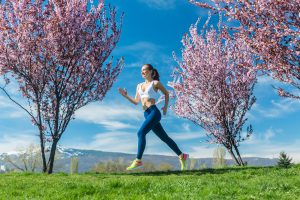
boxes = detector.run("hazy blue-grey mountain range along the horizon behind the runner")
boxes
[0,147,277,172]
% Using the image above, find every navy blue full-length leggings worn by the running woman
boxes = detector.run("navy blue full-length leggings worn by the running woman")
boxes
[137,105,182,159]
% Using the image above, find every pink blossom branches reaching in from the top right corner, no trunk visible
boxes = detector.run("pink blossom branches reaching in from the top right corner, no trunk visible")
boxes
[189,0,300,99]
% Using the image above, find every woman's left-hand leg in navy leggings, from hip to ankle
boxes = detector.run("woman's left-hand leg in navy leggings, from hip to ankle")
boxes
[136,110,160,159]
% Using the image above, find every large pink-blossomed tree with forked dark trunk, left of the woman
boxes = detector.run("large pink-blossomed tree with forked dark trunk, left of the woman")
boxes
[0,0,123,173]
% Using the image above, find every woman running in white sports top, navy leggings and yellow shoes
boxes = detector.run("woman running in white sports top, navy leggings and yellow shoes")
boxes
[119,64,189,170]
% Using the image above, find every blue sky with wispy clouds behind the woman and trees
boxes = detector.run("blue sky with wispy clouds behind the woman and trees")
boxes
[0,0,300,162]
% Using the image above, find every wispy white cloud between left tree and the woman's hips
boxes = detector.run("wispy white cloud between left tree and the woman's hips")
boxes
[75,102,144,130]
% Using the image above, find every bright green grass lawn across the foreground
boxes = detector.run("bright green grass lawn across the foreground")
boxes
[0,165,300,200]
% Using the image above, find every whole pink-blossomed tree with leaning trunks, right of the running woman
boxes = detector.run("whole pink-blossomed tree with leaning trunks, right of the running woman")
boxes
[169,14,256,165]
